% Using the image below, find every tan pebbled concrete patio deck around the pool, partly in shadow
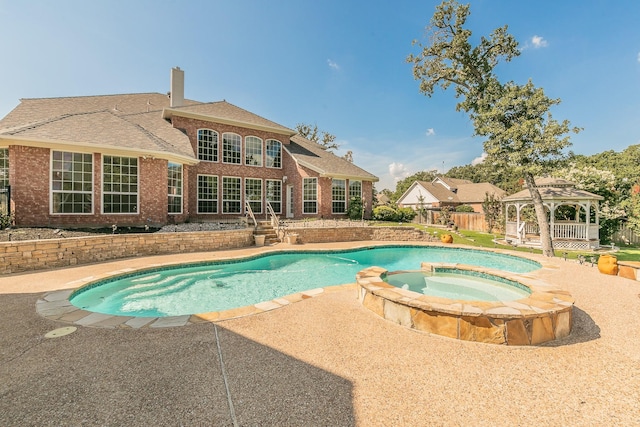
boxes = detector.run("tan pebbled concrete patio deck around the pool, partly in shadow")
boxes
[0,242,640,426]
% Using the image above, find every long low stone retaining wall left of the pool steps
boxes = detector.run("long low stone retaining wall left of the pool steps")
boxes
[0,229,253,274]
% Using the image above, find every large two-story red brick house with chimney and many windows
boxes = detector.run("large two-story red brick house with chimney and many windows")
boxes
[0,68,378,227]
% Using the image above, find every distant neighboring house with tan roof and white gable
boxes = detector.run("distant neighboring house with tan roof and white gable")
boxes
[397,177,507,212]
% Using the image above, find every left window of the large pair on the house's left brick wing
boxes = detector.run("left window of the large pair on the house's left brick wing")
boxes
[51,151,93,214]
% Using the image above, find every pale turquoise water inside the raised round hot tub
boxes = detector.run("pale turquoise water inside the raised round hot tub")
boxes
[385,270,531,301]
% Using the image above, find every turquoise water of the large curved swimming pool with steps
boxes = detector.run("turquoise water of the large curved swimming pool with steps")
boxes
[70,246,540,317]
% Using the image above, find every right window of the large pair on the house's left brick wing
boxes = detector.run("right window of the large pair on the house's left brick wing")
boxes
[102,156,138,213]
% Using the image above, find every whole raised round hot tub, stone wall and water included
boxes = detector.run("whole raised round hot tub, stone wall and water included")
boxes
[356,263,574,345]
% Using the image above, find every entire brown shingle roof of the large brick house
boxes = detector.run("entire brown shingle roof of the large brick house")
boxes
[0,93,378,181]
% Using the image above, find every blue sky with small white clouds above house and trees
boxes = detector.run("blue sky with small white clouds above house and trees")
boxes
[0,0,640,190]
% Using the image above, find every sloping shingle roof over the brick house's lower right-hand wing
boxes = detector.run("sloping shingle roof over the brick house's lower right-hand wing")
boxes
[284,135,378,181]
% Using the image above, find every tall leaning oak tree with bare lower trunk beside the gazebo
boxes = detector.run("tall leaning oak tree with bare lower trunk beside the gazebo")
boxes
[407,0,578,256]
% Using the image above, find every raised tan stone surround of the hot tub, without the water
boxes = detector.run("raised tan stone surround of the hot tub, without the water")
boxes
[356,263,574,345]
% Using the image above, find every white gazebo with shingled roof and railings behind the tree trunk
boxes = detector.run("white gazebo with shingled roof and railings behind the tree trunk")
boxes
[502,178,603,250]
